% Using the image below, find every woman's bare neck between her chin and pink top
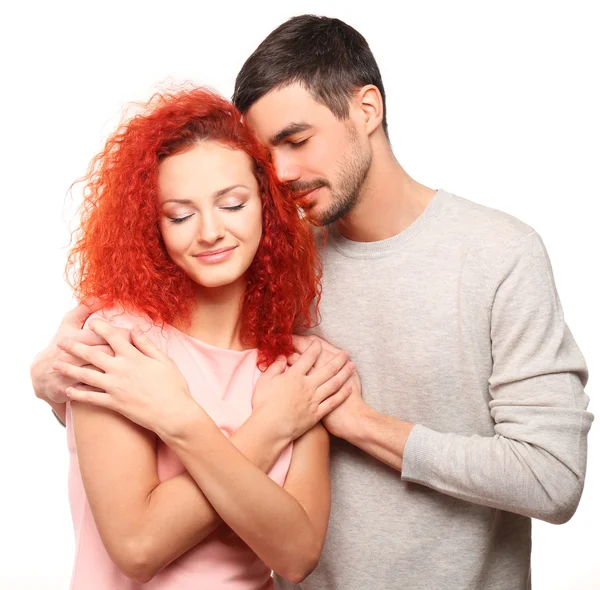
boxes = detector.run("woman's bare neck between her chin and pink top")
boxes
[175,279,247,350]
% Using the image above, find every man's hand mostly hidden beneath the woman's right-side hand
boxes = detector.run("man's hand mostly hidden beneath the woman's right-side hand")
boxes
[288,336,372,439]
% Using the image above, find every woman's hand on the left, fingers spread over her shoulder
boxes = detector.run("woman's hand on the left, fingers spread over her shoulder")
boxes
[53,320,197,438]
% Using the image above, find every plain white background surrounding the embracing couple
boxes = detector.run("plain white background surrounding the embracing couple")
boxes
[0,0,600,590]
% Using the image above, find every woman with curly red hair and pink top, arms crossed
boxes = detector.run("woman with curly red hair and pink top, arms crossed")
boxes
[55,89,353,590]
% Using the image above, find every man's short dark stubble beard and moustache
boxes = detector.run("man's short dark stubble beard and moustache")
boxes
[290,129,372,225]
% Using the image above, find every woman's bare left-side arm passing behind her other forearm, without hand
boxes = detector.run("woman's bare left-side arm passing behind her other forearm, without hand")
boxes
[71,402,298,583]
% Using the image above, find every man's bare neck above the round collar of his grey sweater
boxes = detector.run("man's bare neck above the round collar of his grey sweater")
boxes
[337,141,435,242]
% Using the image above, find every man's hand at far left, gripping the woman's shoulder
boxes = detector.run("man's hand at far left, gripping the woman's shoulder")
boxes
[30,302,112,405]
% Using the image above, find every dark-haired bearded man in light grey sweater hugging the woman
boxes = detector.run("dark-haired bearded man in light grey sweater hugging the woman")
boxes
[32,16,593,590]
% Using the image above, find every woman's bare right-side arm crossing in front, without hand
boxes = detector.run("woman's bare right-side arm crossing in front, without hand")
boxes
[165,406,329,583]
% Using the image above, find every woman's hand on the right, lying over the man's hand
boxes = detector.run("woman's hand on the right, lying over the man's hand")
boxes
[252,341,354,441]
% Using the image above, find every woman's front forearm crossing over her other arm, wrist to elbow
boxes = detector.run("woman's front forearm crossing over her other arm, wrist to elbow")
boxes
[163,407,321,577]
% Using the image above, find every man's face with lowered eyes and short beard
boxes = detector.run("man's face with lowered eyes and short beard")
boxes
[246,84,371,225]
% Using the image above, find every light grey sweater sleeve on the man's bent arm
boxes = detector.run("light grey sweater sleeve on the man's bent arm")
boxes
[402,232,593,524]
